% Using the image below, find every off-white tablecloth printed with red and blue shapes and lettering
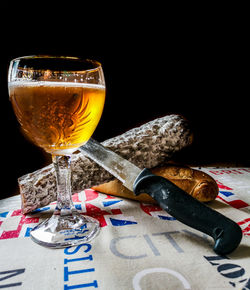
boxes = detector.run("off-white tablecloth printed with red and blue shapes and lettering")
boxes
[0,167,250,290]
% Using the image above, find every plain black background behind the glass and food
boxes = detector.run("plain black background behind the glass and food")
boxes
[0,7,250,198]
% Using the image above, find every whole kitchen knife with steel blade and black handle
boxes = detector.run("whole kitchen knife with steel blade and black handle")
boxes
[79,138,242,255]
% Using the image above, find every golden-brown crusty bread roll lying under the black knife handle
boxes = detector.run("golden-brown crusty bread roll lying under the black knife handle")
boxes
[92,165,219,204]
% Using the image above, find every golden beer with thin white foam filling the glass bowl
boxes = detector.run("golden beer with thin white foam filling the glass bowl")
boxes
[9,81,105,155]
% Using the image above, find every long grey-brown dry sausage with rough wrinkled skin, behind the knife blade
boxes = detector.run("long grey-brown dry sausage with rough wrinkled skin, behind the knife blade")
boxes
[18,115,193,214]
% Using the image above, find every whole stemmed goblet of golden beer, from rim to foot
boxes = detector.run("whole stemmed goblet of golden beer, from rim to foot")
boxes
[8,56,105,248]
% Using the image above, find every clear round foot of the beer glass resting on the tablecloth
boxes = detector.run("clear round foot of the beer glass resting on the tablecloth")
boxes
[30,213,100,248]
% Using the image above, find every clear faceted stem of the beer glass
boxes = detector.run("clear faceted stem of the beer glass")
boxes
[52,155,75,216]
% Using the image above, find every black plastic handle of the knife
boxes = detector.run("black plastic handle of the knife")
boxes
[134,169,242,255]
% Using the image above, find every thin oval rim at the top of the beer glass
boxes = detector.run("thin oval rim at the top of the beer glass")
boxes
[10,54,102,73]
